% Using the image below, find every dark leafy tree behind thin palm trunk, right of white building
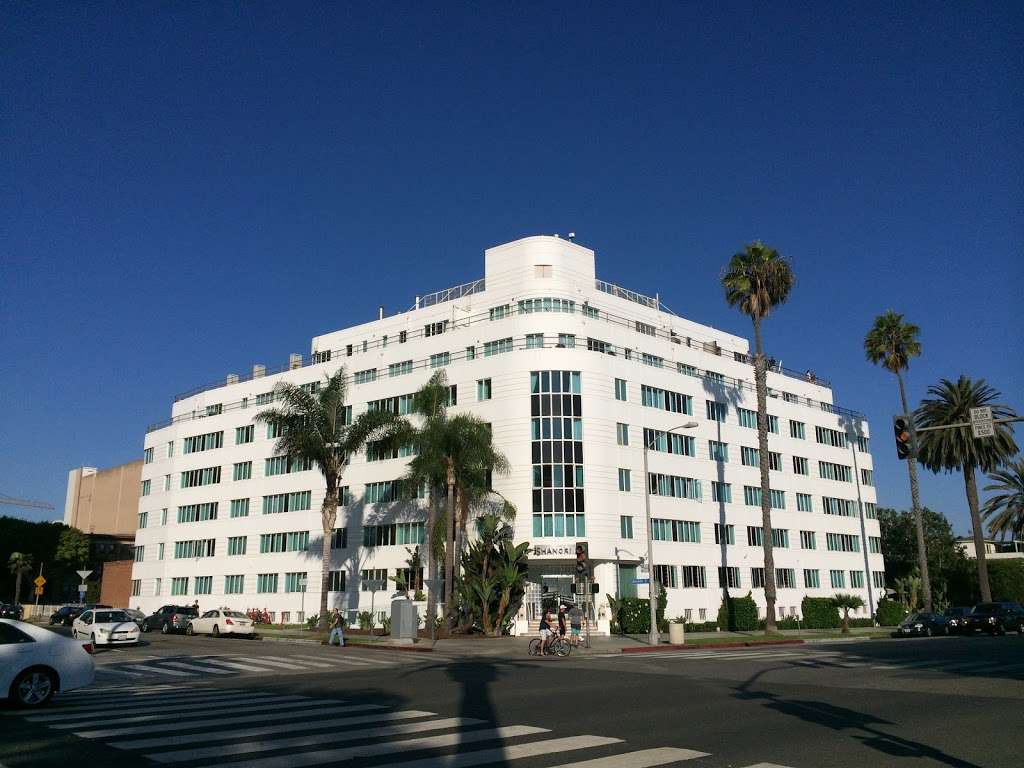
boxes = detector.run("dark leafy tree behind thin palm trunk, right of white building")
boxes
[878,507,973,609]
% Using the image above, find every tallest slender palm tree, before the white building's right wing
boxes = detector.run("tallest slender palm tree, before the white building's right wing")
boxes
[716,241,794,634]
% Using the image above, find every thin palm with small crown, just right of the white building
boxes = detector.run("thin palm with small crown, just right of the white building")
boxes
[864,309,932,612]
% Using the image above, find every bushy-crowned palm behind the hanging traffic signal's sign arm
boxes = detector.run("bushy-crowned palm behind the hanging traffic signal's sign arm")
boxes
[915,375,1017,602]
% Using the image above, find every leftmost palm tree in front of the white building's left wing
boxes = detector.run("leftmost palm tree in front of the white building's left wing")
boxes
[256,368,408,631]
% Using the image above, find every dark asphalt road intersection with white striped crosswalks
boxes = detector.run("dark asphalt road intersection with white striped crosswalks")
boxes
[0,634,1024,768]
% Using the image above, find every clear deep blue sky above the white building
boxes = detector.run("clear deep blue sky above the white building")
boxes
[0,2,1024,532]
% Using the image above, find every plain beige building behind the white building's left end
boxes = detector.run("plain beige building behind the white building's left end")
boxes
[63,461,142,542]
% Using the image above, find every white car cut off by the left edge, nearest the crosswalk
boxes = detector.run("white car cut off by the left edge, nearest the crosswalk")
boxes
[0,618,96,707]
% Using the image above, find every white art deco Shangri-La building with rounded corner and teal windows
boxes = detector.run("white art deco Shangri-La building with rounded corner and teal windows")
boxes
[131,237,884,629]
